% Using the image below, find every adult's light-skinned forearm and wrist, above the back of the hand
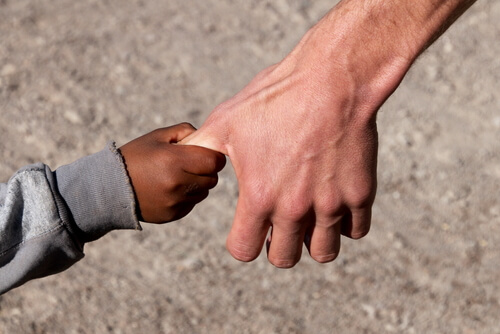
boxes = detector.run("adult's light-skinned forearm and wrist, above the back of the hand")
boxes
[288,0,475,117]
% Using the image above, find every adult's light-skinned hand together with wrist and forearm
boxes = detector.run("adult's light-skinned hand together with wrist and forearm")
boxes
[182,0,475,268]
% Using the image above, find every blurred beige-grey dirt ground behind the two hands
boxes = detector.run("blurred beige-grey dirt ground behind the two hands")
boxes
[0,0,500,334]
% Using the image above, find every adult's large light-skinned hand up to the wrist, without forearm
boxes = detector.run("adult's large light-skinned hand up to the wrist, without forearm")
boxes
[187,46,377,268]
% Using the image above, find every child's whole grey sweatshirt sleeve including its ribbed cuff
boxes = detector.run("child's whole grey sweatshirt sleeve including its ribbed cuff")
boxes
[0,143,140,294]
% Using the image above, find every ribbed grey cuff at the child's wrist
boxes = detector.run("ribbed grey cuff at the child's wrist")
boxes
[55,142,142,242]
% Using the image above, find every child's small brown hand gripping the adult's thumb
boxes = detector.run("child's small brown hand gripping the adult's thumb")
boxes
[120,123,226,223]
